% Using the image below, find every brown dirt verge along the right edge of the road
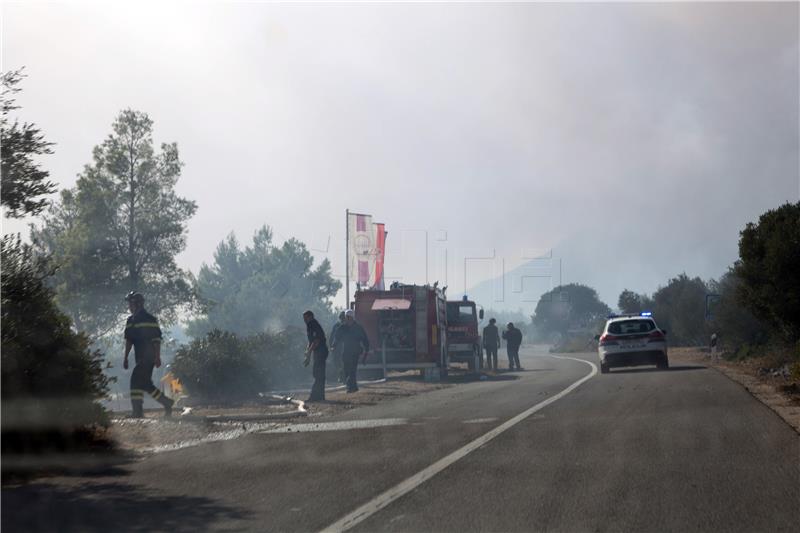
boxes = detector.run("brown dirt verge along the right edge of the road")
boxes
[669,348,800,433]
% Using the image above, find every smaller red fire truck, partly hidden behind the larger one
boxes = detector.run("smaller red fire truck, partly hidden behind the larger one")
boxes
[447,295,483,371]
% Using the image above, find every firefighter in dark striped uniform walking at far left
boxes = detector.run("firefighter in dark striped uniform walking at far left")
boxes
[122,291,175,418]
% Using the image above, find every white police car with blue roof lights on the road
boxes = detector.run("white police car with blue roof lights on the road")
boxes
[595,312,669,374]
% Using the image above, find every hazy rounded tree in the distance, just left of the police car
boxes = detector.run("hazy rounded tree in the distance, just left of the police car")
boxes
[533,283,611,335]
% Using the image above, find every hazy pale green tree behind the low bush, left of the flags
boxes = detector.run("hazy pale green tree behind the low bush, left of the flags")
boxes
[188,226,342,338]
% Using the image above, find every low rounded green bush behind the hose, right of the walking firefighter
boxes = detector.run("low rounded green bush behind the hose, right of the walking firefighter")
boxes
[172,328,310,404]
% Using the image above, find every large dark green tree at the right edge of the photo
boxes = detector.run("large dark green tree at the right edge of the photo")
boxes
[734,202,800,342]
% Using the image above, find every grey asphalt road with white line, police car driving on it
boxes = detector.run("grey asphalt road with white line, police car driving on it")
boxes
[2,350,800,533]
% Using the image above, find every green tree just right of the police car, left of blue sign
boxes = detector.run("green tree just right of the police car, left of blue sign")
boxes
[653,273,709,344]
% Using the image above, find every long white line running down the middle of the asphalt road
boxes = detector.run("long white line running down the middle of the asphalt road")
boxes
[323,355,597,533]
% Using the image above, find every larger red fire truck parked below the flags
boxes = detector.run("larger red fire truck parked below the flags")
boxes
[354,283,447,377]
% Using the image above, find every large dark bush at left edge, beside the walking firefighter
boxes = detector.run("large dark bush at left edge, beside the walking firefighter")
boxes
[2,236,108,451]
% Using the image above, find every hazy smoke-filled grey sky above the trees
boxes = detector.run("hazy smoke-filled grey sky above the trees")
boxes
[2,2,800,307]
